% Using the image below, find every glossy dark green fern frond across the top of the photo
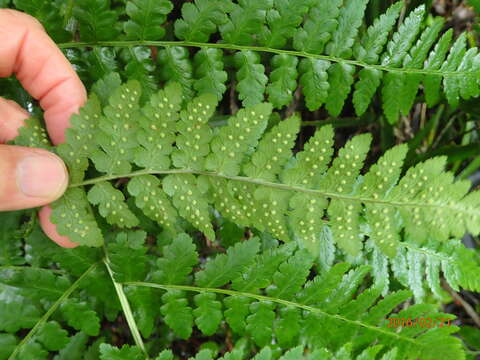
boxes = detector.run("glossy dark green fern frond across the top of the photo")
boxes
[50,0,480,124]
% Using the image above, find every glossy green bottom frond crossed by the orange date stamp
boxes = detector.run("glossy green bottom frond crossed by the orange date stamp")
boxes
[116,236,462,359]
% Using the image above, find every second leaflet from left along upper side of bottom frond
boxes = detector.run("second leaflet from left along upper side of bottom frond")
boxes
[195,238,260,287]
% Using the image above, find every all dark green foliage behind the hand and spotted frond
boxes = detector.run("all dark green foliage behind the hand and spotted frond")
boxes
[0,0,480,360]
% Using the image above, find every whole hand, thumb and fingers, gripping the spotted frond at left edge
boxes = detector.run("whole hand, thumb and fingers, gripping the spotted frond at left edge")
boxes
[0,9,86,247]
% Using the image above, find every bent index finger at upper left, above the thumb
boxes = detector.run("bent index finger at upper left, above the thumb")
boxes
[0,9,86,144]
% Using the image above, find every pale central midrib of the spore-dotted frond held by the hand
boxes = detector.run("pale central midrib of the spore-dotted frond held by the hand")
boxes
[69,169,480,216]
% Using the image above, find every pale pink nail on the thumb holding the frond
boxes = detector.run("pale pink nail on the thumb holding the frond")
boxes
[17,154,67,199]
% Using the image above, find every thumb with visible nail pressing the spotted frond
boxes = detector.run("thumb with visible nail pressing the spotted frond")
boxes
[0,145,68,211]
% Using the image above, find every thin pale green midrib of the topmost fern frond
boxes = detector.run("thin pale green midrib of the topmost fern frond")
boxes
[57,40,477,76]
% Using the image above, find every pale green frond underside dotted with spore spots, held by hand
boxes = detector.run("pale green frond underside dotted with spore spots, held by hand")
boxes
[17,81,480,256]
